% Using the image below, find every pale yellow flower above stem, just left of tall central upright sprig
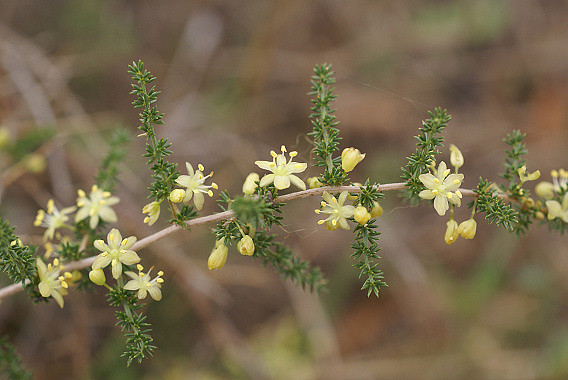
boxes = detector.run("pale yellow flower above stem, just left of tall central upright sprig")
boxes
[255,145,308,190]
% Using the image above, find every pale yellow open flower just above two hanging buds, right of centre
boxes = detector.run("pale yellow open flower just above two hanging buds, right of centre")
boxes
[418,161,463,215]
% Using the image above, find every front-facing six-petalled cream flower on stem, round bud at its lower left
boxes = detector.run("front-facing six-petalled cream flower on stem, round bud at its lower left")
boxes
[92,228,140,278]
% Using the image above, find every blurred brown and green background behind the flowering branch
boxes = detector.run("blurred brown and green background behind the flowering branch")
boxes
[0,0,568,379]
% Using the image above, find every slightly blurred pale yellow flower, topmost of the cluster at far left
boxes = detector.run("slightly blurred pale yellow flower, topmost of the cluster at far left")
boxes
[75,185,120,230]
